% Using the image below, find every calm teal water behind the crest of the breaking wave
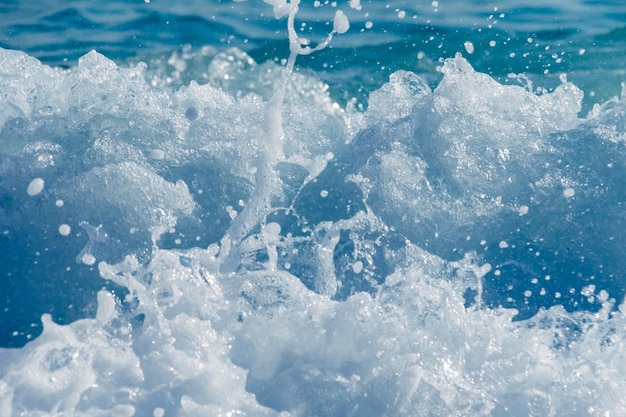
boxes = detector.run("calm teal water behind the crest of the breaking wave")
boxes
[0,0,626,109]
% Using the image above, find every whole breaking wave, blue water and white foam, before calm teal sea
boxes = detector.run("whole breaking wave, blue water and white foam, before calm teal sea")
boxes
[0,17,626,416]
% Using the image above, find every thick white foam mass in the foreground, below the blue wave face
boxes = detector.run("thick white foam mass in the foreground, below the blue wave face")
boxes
[0,244,625,416]
